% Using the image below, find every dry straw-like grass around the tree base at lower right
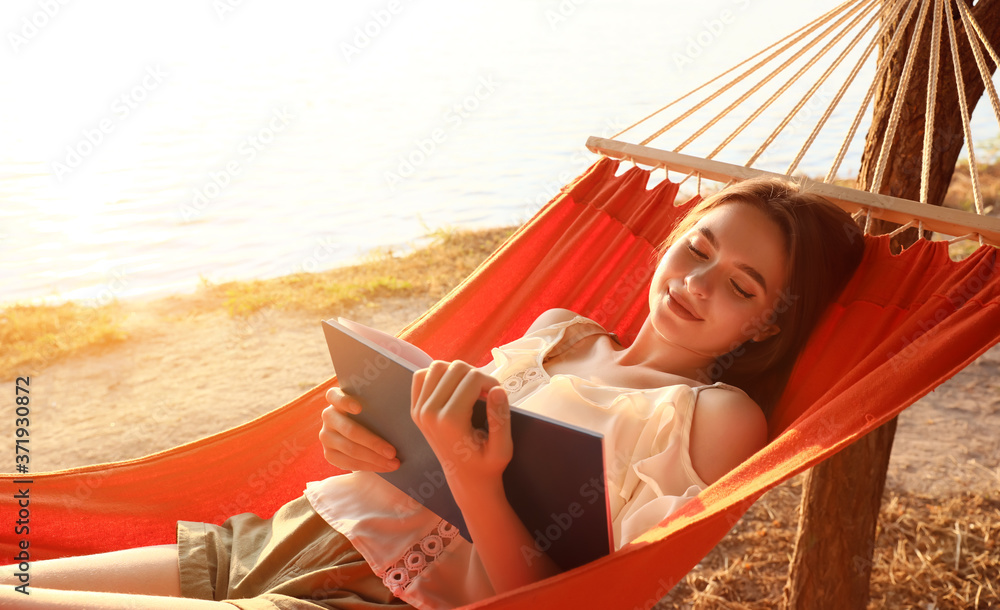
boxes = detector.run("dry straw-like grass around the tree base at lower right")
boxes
[659,479,1000,610]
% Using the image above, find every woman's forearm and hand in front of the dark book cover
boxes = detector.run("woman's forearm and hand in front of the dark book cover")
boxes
[411,361,559,593]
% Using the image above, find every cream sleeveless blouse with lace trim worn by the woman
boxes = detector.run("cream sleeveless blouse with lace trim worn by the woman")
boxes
[305,316,729,608]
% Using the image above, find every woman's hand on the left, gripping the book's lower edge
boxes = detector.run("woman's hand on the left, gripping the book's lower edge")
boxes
[319,387,399,472]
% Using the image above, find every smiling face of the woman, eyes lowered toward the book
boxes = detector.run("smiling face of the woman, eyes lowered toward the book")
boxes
[649,202,790,357]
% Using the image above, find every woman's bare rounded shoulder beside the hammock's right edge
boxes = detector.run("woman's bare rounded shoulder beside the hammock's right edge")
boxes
[690,388,767,484]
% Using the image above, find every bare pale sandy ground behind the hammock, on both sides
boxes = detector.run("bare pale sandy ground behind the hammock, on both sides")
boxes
[7,297,1000,496]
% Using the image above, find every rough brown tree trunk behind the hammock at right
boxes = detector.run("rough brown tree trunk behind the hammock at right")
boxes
[784,0,1000,610]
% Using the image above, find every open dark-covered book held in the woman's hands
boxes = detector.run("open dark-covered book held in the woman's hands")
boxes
[323,320,613,569]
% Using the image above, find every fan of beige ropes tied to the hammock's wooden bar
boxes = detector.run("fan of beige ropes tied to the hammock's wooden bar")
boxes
[596,0,1000,245]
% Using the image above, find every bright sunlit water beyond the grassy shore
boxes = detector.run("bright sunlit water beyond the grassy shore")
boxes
[0,0,996,302]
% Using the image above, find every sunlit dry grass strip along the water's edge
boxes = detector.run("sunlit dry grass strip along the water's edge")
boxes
[0,227,514,376]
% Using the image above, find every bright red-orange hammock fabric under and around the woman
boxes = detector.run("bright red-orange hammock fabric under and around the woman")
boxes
[0,158,1000,608]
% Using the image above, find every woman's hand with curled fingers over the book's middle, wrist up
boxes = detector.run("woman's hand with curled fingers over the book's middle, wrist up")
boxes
[410,360,514,499]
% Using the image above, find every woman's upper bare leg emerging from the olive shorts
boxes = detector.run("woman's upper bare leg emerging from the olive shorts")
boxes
[0,544,181,597]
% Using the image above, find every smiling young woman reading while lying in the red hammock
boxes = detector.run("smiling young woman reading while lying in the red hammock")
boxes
[0,180,864,608]
